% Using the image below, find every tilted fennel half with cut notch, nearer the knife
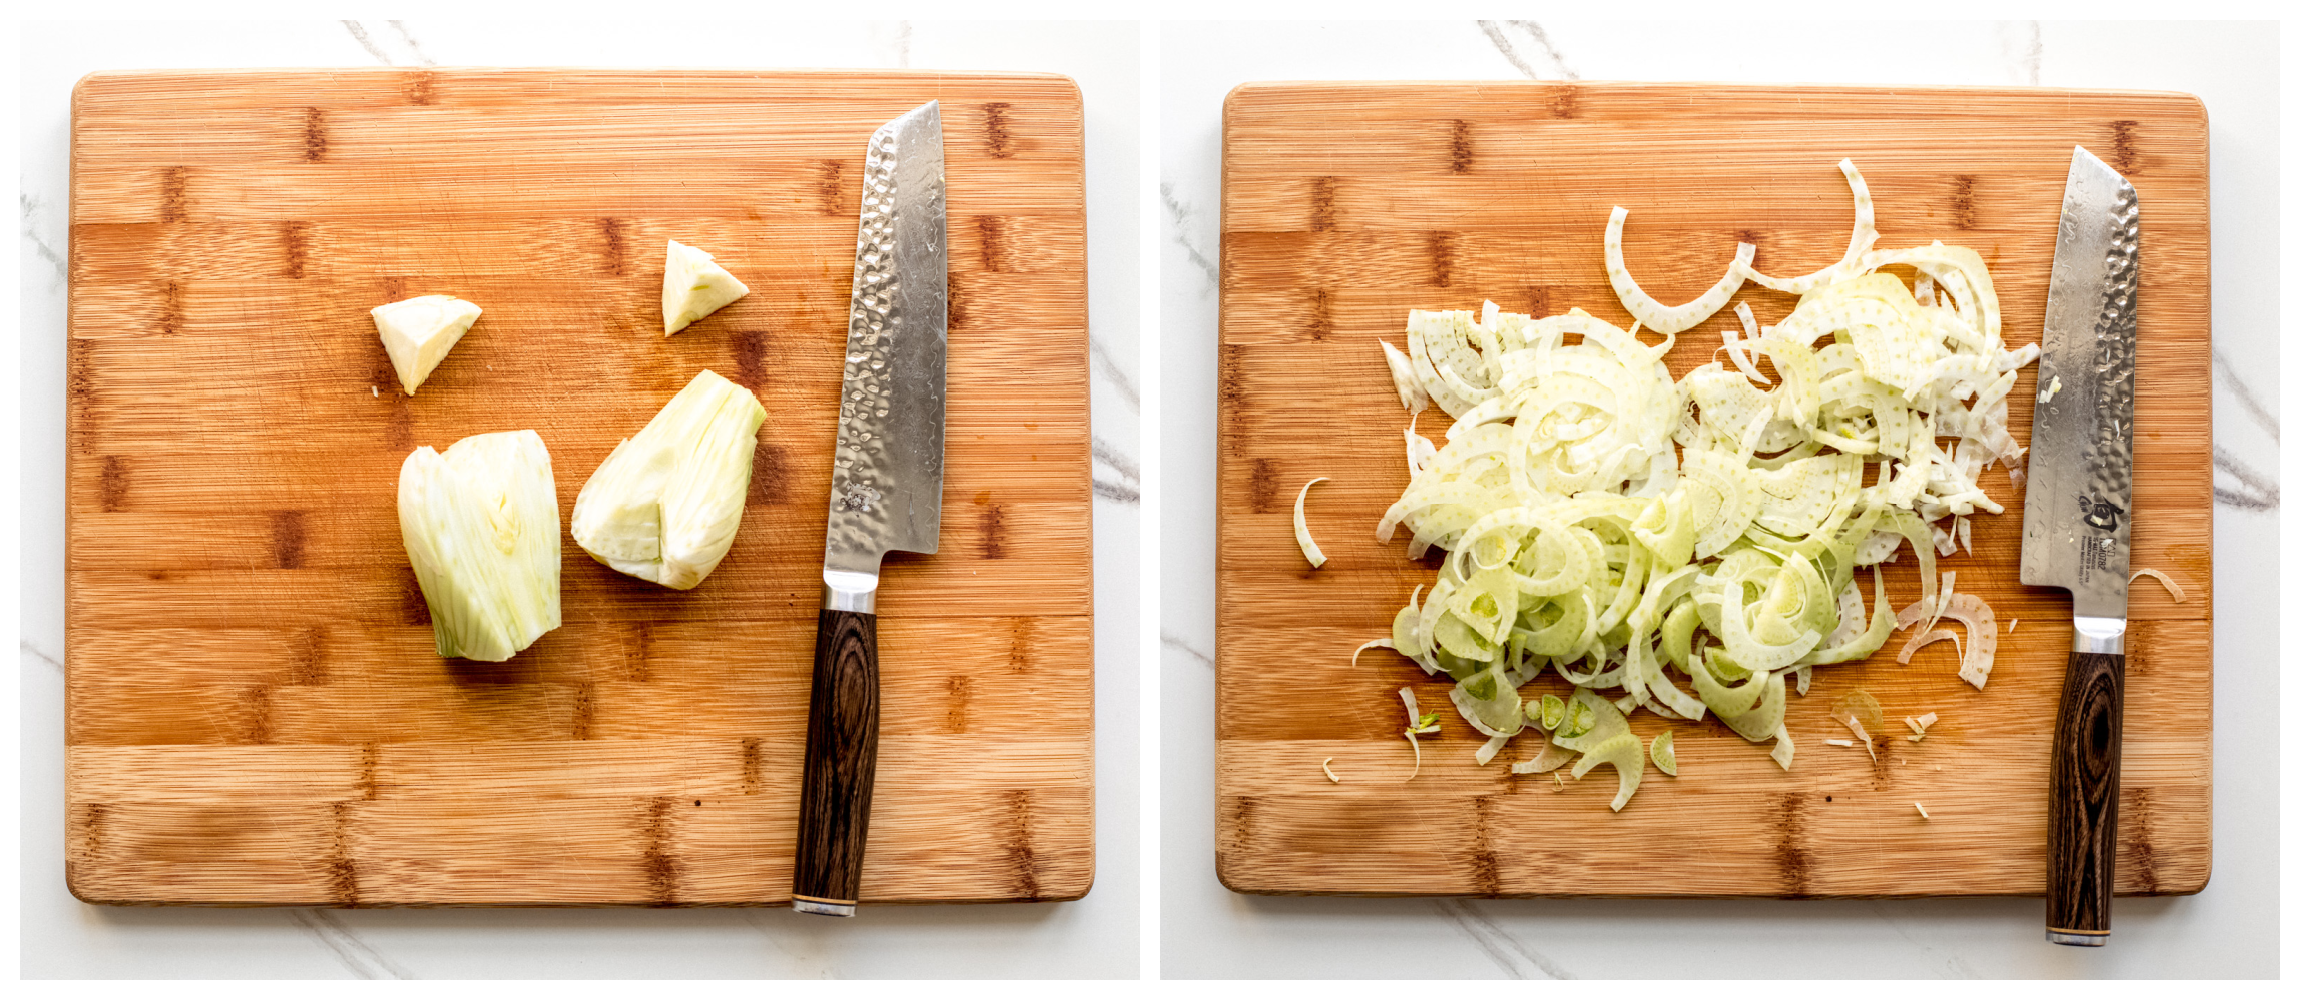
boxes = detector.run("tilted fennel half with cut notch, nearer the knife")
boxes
[568,368,766,591]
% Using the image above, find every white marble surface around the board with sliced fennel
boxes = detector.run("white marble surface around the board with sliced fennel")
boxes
[1159,21,2279,979]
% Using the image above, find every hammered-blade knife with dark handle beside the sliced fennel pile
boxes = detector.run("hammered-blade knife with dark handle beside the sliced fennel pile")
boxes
[2019,145,2141,947]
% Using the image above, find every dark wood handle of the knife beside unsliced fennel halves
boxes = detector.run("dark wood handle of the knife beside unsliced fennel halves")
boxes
[791,607,879,917]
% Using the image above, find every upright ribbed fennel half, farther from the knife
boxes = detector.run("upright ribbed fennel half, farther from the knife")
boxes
[400,430,559,662]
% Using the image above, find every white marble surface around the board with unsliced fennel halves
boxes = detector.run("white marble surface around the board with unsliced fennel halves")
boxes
[18,18,1141,979]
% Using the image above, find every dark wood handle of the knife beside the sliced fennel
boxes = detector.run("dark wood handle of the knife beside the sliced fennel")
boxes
[2045,653,2125,945]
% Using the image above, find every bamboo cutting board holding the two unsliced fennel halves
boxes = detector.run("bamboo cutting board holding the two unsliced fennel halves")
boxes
[67,69,1093,906]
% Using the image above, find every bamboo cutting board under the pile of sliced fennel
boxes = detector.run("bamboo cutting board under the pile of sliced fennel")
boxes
[1217,83,2213,897]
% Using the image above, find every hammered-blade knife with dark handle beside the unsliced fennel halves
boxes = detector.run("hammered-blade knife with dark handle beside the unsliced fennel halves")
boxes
[791,101,950,917]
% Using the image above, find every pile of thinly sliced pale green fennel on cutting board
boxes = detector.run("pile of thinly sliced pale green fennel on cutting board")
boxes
[1375,161,2038,809]
